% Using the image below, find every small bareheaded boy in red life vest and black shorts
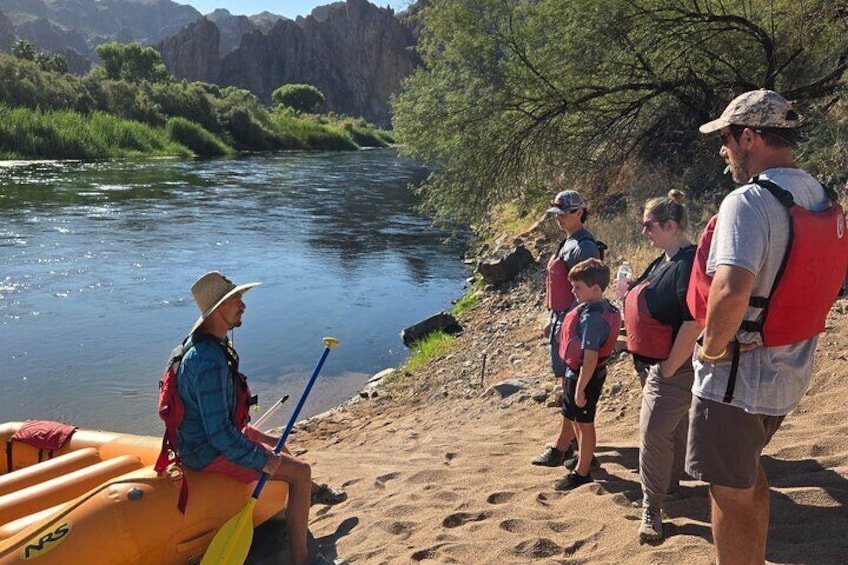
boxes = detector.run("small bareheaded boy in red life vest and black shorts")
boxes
[554,259,621,490]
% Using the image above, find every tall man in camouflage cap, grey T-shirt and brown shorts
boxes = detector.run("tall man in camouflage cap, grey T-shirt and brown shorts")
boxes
[686,90,846,565]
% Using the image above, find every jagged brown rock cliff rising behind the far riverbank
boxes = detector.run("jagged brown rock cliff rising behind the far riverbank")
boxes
[159,0,418,126]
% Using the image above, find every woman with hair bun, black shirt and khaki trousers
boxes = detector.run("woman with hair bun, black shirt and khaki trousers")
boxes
[616,190,701,542]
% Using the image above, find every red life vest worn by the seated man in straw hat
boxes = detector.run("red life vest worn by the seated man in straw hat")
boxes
[153,334,256,514]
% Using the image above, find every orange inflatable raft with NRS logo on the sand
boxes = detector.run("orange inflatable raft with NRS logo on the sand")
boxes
[0,422,288,565]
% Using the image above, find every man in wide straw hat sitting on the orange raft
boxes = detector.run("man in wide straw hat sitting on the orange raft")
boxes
[177,271,334,565]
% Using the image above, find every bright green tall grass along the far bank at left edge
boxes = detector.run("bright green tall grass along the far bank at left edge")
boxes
[0,105,192,159]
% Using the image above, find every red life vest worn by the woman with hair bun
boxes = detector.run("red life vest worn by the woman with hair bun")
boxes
[624,276,673,361]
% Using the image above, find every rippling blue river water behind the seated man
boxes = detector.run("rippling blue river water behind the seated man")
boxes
[0,150,467,434]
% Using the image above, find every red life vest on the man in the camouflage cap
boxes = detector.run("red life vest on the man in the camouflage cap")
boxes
[686,176,848,347]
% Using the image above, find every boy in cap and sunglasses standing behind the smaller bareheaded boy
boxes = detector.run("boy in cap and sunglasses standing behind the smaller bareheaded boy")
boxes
[531,190,601,467]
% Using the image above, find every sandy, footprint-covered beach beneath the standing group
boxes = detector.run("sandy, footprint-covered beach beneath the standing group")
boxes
[278,262,848,565]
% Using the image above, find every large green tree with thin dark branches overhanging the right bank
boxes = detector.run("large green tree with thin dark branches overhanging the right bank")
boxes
[394,0,848,221]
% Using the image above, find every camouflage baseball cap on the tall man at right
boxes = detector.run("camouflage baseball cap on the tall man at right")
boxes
[698,88,804,133]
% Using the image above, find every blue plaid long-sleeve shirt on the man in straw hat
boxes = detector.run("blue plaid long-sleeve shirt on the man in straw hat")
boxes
[177,334,268,471]
